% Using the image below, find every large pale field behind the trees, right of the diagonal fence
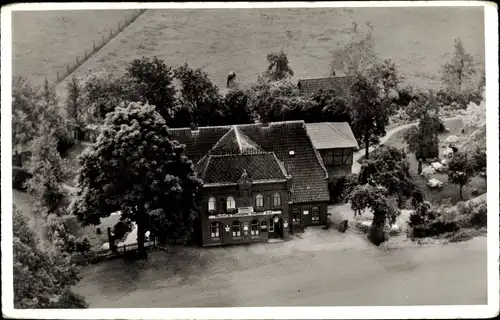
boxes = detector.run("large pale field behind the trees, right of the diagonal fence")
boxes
[53,7,484,97]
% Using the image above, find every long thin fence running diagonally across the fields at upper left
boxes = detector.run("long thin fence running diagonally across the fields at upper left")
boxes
[53,9,146,87]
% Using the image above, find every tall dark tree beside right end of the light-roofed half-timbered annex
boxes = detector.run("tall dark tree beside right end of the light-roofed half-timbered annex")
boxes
[350,76,390,159]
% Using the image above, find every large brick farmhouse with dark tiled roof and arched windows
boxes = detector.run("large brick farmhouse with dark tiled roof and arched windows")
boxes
[170,121,358,246]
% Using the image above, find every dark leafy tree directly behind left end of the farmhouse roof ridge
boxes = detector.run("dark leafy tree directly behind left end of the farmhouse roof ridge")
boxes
[172,64,222,126]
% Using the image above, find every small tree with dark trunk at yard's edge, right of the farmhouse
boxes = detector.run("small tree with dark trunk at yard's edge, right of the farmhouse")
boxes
[349,184,399,246]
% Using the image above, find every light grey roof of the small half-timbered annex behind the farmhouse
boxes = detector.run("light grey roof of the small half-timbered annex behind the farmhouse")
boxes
[306,122,359,150]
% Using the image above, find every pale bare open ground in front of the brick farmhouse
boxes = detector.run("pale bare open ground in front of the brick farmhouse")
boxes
[75,229,487,308]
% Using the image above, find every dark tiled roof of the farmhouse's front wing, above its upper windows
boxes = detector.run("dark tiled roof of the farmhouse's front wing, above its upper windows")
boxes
[198,152,287,184]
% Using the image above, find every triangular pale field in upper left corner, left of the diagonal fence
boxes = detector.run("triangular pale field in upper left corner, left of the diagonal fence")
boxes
[12,10,141,85]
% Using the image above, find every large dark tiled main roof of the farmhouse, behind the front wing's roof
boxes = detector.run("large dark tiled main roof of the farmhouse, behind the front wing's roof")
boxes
[169,121,330,203]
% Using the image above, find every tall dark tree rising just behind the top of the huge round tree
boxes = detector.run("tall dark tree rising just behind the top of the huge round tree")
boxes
[127,57,177,123]
